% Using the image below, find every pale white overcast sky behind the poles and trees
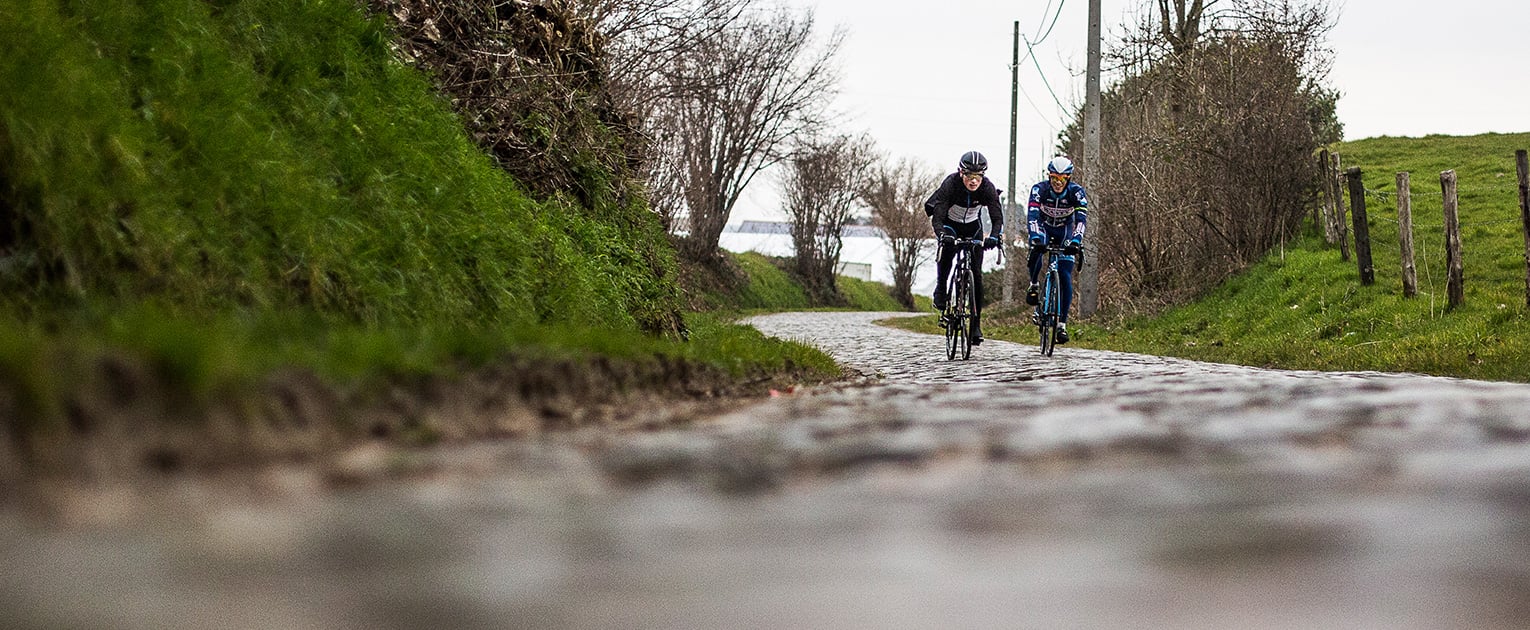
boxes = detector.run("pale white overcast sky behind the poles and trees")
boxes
[733,0,1530,222]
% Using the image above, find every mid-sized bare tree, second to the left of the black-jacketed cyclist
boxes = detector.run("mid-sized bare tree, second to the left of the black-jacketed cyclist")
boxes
[782,136,875,304]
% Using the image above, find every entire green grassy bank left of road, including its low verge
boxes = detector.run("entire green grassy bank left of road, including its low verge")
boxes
[0,0,838,446]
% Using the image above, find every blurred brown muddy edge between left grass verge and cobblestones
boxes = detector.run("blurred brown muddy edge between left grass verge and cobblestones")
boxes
[0,350,851,520]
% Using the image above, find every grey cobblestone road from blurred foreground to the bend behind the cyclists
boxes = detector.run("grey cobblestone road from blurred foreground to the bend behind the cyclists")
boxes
[0,313,1530,628]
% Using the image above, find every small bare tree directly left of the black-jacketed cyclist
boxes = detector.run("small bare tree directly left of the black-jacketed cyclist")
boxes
[860,158,941,309]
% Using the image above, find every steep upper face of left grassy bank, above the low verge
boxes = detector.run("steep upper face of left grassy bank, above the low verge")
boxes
[0,0,678,329]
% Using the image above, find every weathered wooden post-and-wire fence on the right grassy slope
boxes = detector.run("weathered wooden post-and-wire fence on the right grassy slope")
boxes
[1313,150,1530,311]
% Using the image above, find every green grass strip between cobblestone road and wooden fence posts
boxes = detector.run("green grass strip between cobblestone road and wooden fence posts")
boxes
[1079,243,1530,382]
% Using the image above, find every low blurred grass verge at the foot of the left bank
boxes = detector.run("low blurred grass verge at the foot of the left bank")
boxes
[0,309,840,443]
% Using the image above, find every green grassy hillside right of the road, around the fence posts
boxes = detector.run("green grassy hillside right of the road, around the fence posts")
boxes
[909,133,1530,382]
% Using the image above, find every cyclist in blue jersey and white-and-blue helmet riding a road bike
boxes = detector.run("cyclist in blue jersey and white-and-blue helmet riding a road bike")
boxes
[1025,156,1089,344]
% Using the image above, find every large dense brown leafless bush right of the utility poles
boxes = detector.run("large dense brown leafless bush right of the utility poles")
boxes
[1066,0,1342,309]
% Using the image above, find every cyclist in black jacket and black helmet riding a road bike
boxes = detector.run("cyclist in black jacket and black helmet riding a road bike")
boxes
[924,151,1004,346]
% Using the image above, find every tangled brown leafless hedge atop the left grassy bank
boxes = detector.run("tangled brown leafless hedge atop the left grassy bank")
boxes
[367,0,630,201]
